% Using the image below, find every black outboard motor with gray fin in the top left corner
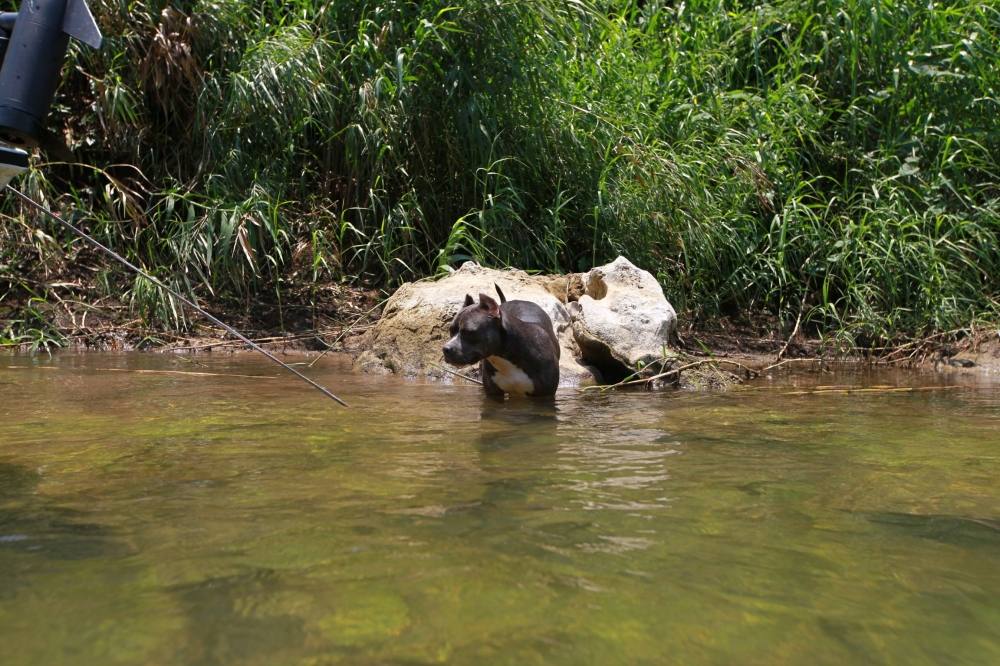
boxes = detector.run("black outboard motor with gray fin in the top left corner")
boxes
[0,0,101,186]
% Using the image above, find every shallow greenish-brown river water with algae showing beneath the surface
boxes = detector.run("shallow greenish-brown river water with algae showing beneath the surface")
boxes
[0,354,1000,666]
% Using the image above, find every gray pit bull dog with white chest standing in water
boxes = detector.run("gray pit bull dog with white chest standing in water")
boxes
[442,285,559,397]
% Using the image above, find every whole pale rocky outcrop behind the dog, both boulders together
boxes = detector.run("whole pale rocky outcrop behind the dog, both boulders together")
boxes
[355,257,676,386]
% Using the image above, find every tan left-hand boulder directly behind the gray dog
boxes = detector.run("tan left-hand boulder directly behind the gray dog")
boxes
[355,261,599,386]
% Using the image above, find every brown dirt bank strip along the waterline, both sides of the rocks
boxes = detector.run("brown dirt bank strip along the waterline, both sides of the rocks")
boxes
[0,274,1000,374]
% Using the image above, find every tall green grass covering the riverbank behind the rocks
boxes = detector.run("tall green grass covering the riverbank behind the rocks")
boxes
[0,0,1000,343]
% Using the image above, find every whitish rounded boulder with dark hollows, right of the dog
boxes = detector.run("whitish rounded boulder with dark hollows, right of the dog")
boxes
[570,257,677,380]
